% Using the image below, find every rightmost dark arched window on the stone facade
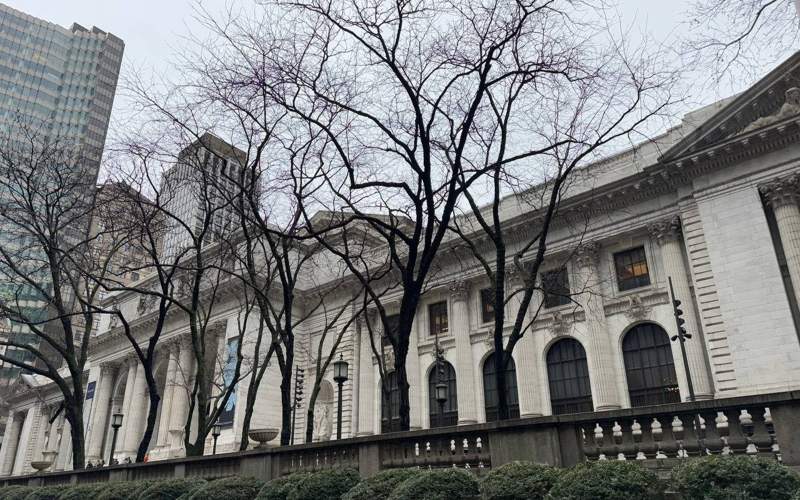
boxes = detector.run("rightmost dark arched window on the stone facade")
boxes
[622,323,681,406]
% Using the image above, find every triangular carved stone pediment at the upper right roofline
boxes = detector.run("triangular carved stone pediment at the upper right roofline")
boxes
[660,52,800,163]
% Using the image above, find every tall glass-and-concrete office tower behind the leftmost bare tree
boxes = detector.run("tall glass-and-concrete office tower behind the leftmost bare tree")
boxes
[0,3,124,385]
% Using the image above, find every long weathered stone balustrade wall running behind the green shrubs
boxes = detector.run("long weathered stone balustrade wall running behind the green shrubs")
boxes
[0,392,800,486]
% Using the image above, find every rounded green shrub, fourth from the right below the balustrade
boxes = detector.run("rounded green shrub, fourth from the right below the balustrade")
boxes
[389,469,480,500]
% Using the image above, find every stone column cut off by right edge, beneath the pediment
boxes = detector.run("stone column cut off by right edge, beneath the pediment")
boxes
[758,174,800,310]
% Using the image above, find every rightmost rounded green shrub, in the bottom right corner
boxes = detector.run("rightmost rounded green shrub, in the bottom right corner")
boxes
[670,455,800,500]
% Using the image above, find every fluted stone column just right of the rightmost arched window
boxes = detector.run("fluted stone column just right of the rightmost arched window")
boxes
[650,215,714,401]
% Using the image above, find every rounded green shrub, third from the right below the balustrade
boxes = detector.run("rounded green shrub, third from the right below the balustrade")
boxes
[481,462,560,500]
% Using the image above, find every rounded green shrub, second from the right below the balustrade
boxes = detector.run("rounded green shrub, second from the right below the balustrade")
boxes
[550,461,662,500]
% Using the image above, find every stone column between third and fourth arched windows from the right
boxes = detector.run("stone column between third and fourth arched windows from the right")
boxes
[449,281,478,425]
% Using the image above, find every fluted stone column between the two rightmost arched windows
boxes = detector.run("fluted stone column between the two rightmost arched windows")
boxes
[576,242,622,411]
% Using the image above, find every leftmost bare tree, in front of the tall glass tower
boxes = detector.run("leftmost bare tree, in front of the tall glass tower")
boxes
[0,121,121,469]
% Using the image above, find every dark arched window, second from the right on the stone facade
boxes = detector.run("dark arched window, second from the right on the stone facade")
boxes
[547,339,594,415]
